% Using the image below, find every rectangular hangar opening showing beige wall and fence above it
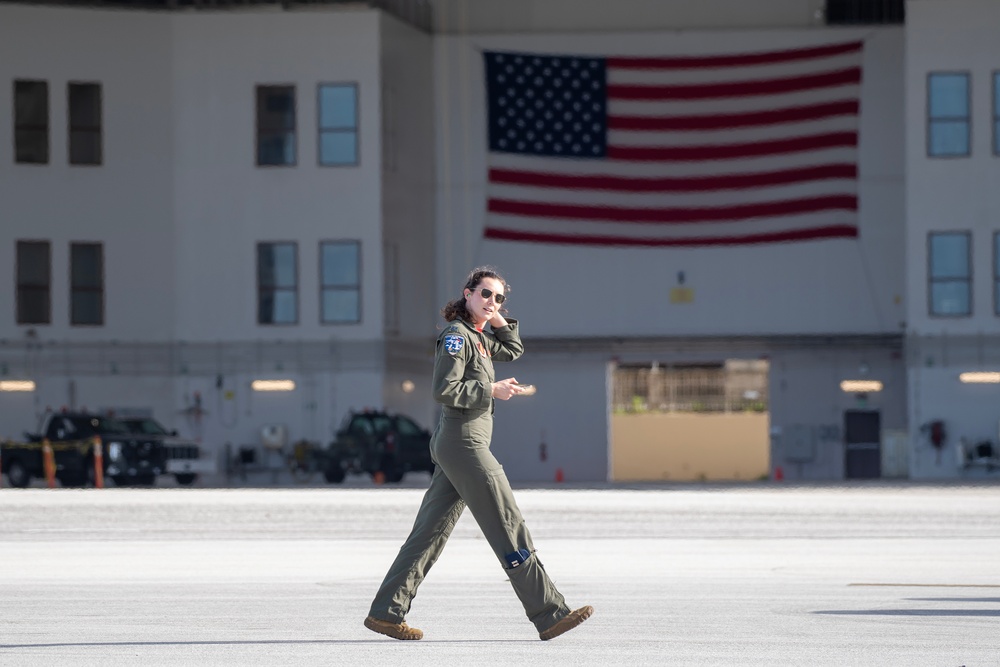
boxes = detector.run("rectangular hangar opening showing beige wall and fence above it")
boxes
[611,359,770,481]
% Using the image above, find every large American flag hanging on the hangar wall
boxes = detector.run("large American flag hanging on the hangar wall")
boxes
[484,42,862,246]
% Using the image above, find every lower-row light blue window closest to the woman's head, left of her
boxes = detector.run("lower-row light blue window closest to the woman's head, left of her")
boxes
[320,241,361,324]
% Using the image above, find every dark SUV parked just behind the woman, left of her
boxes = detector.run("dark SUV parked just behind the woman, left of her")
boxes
[323,411,434,484]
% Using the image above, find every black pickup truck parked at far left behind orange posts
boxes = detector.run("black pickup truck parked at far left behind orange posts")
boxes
[0,412,173,488]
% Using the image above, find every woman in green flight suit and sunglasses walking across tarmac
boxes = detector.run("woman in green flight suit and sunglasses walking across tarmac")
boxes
[365,268,594,639]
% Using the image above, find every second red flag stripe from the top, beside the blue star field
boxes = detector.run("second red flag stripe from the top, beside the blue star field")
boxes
[607,67,861,101]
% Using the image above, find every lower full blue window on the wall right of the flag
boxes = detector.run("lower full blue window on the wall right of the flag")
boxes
[927,232,972,317]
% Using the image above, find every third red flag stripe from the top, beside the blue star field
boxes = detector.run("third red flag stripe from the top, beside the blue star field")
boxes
[608,100,859,132]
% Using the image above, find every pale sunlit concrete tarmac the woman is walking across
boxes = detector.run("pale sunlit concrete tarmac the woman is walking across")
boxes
[0,479,1000,667]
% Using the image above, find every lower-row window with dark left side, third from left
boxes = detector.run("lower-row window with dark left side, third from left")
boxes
[257,243,299,324]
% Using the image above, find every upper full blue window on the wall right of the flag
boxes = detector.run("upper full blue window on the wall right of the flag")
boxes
[927,72,969,157]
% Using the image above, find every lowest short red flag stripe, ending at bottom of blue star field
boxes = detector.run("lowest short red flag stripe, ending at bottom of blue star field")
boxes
[607,132,858,162]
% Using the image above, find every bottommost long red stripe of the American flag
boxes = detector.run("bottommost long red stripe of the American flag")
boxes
[485,225,858,247]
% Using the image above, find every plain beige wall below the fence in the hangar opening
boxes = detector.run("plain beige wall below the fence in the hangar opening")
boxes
[611,413,770,481]
